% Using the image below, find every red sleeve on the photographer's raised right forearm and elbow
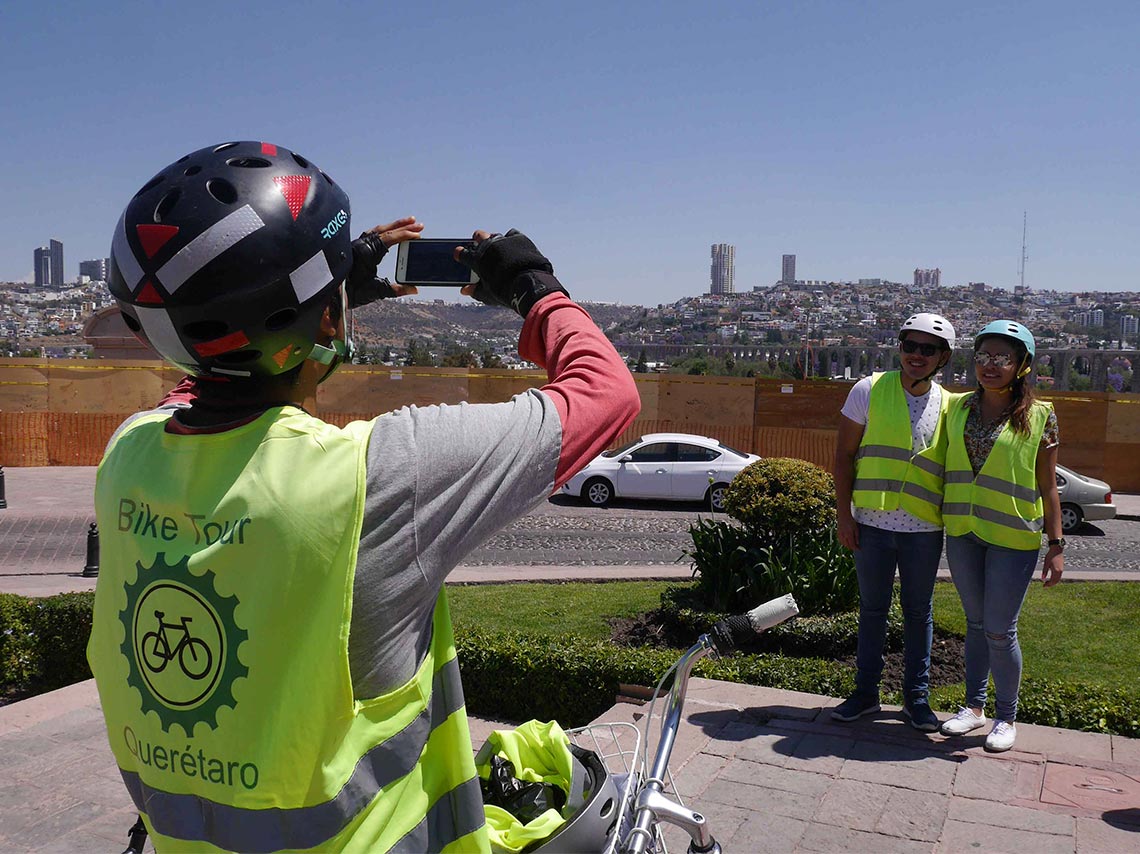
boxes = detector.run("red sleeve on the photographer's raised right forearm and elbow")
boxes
[519,294,641,489]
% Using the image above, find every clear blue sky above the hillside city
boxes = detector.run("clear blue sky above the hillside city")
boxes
[0,0,1140,304]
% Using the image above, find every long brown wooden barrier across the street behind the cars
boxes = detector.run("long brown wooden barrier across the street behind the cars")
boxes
[0,359,1140,493]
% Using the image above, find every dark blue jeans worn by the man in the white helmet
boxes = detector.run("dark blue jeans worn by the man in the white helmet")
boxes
[855,524,942,703]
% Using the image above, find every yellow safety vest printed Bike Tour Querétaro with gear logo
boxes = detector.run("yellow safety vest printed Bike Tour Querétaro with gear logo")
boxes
[88,407,489,852]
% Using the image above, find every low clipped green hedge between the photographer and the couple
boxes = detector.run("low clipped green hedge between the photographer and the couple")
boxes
[456,632,854,726]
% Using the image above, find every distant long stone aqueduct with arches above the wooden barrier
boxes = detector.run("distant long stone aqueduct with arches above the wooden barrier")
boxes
[617,343,1140,393]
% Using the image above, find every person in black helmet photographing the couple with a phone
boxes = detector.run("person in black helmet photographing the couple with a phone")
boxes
[88,141,640,852]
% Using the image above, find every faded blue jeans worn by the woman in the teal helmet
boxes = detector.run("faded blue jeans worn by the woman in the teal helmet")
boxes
[946,534,1037,723]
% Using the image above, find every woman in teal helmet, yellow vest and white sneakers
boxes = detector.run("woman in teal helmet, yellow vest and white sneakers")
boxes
[942,320,1065,751]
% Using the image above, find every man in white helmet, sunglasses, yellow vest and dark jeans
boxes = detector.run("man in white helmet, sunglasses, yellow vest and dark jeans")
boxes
[831,312,954,732]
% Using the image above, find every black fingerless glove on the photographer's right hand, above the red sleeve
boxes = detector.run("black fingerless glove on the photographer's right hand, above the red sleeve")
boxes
[459,228,570,318]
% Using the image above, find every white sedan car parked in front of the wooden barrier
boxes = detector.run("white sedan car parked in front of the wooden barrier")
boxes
[562,433,759,511]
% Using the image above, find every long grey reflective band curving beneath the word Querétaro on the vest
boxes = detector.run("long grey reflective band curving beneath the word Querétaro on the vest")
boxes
[120,659,465,854]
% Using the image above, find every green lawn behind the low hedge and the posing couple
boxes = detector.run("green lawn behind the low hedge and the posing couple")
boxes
[448,581,1140,688]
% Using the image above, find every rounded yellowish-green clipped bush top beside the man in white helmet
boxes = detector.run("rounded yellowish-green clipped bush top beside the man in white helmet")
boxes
[724,457,836,545]
